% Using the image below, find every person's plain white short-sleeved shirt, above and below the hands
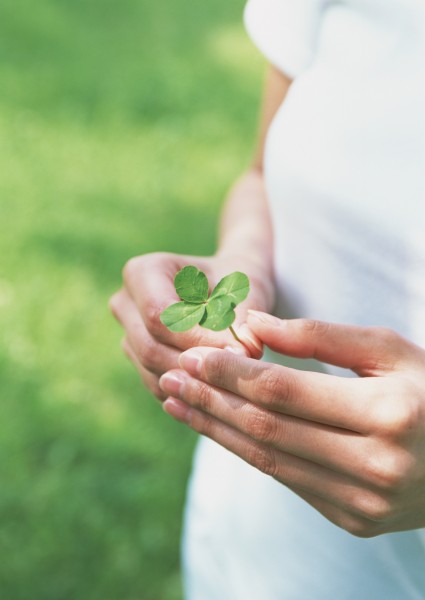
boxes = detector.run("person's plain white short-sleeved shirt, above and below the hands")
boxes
[185,0,425,600]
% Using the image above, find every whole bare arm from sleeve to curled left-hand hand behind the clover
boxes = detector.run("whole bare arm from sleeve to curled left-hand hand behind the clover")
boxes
[110,68,291,399]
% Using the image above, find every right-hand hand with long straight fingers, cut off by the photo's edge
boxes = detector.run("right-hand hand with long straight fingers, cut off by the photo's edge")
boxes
[160,313,425,537]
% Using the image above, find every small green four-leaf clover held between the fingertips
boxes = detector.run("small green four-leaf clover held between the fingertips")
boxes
[160,266,249,342]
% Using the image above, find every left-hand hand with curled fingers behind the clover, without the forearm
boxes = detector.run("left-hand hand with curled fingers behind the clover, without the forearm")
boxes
[110,253,272,399]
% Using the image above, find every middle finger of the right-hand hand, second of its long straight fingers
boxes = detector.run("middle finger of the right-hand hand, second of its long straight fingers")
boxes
[159,370,376,481]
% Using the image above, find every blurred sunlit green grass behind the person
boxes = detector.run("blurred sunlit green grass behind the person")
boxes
[0,0,262,600]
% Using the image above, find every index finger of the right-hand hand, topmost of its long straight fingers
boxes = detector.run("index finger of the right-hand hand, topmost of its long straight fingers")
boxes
[179,348,374,433]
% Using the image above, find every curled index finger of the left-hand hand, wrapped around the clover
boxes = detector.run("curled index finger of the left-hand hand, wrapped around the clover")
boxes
[124,254,263,358]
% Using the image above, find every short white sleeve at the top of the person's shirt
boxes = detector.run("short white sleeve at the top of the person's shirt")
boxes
[244,0,324,77]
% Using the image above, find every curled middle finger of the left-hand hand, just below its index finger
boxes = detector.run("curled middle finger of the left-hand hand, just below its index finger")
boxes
[112,290,180,375]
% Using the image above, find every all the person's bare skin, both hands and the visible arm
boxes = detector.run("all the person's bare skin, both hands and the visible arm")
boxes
[111,67,425,537]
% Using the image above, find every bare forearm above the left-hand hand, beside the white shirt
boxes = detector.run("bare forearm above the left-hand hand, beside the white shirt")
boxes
[217,168,274,302]
